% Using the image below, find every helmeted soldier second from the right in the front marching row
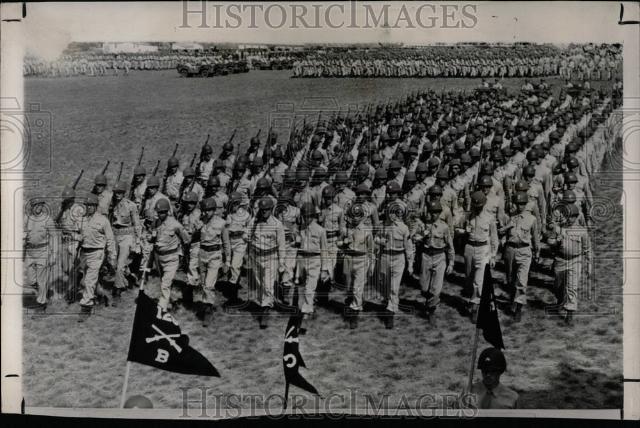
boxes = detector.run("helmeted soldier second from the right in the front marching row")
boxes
[504,192,540,322]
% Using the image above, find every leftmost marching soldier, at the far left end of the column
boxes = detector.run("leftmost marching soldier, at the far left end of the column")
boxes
[24,198,56,313]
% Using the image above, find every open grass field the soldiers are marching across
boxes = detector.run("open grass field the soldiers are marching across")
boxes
[23,71,624,409]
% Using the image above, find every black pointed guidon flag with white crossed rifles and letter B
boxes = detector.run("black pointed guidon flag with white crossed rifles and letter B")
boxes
[127,291,220,377]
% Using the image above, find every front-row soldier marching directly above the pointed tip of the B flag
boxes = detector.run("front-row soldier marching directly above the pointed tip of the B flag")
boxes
[199,197,231,327]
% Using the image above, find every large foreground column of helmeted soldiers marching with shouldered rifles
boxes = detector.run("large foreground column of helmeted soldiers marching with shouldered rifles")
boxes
[25,79,621,328]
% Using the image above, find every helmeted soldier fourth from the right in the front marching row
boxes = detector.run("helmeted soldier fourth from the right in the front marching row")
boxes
[413,200,455,322]
